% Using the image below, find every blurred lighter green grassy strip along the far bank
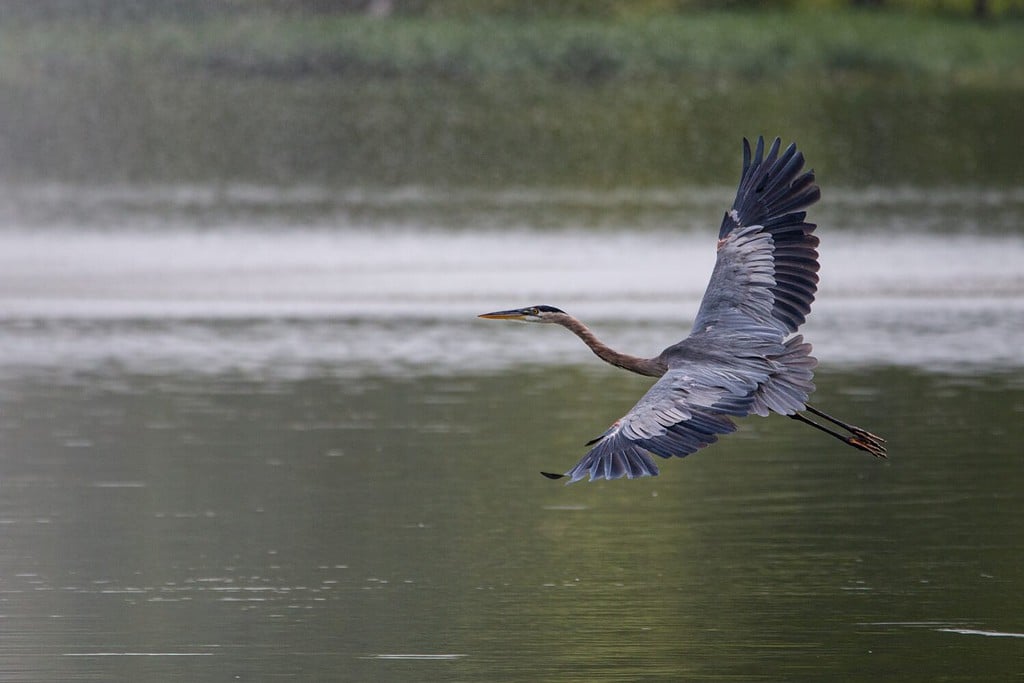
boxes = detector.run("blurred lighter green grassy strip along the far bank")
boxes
[6,11,1024,87]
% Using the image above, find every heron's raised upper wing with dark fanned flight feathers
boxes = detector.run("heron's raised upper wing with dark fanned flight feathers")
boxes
[693,138,820,336]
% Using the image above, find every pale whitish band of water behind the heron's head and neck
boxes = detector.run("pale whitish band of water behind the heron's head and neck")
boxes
[0,187,1024,376]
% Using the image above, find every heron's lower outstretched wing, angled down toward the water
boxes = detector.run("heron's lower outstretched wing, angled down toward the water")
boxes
[565,361,768,483]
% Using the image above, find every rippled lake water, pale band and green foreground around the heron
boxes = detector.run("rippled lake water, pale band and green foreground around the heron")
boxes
[0,184,1024,681]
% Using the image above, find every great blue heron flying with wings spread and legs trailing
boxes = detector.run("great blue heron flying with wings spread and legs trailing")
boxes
[480,137,886,482]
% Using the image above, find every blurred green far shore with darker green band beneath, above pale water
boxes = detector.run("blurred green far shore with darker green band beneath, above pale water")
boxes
[0,2,1024,186]
